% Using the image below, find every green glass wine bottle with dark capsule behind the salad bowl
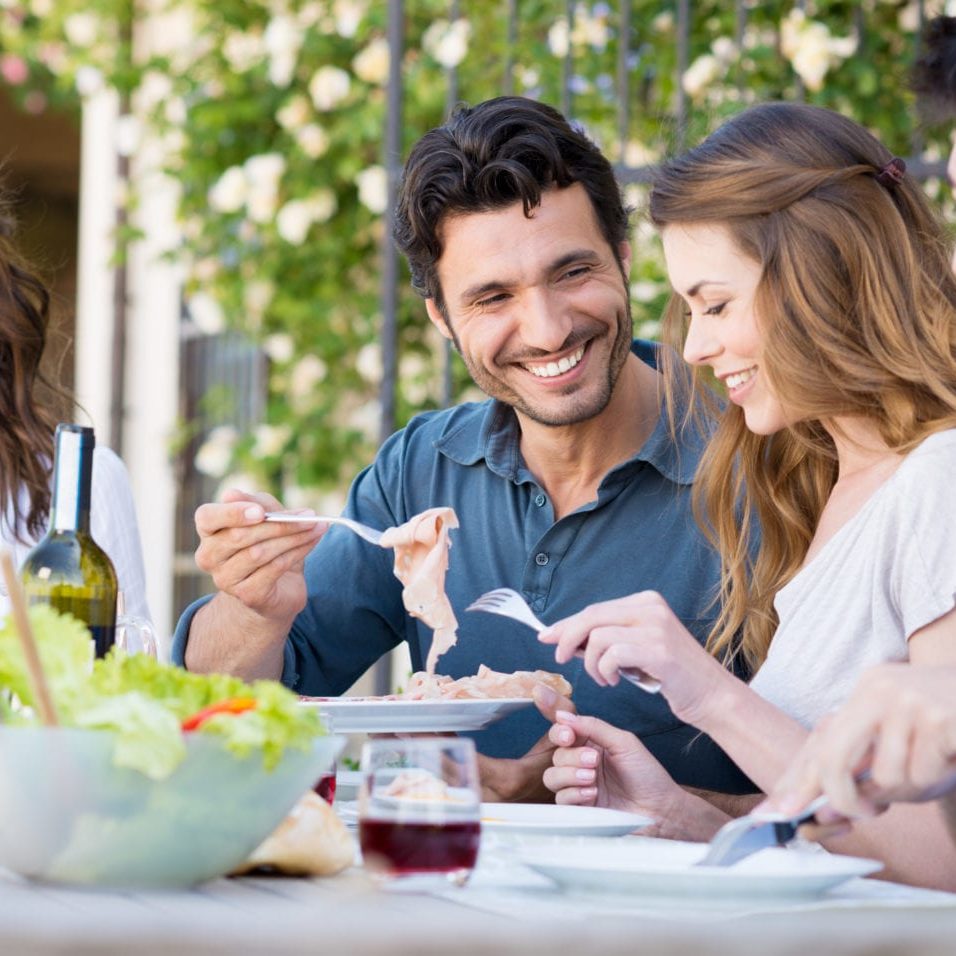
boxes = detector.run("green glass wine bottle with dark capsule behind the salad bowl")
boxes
[20,424,116,657]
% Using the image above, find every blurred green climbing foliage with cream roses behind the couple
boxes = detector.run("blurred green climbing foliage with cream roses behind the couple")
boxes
[0,0,950,504]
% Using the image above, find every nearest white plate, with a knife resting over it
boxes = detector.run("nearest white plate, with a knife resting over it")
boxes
[515,837,881,900]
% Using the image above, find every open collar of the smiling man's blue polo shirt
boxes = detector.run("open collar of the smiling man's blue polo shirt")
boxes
[435,339,705,485]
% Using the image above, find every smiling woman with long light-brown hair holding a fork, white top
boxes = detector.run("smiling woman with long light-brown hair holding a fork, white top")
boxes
[542,103,956,889]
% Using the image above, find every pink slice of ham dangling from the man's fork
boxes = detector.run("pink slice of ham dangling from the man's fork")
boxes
[380,508,458,674]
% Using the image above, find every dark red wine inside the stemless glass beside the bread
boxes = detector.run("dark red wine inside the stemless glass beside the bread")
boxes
[359,820,481,873]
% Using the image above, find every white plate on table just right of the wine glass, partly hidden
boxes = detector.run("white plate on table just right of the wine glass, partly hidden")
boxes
[481,803,653,836]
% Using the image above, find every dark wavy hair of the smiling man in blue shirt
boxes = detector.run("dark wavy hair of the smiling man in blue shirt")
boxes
[393,96,628,313]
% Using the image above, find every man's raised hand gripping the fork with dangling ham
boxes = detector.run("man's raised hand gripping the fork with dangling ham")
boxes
[196,489,328,629]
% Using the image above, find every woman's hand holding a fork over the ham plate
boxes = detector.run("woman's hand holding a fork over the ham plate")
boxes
[538,591,734,727]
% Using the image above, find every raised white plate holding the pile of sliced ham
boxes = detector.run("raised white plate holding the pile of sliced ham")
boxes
[300,697,533,734]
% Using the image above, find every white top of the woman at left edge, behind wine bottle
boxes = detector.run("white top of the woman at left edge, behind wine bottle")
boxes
[0,446,149,619]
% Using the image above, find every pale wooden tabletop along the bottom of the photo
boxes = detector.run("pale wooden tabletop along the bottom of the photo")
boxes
[0,869,956,956]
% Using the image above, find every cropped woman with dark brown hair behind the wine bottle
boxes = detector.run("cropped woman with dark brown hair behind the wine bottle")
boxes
[0,199,149,619]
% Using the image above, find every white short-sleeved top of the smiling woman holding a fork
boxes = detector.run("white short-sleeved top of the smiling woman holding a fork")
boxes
[750,429,956,727]
